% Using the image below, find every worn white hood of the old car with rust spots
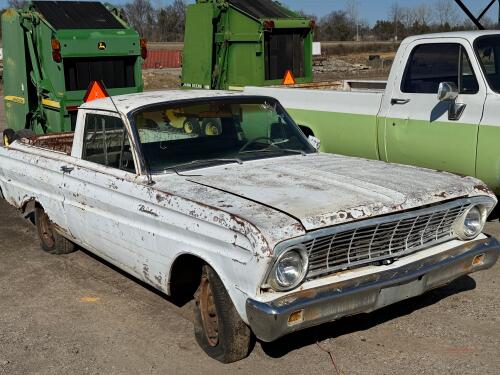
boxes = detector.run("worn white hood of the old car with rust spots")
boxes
[186,154,490,230]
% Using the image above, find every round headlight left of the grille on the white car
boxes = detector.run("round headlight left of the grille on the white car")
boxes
[269,248,309,291]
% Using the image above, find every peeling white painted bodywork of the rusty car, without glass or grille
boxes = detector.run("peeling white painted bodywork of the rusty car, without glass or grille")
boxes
[0,90,495,321]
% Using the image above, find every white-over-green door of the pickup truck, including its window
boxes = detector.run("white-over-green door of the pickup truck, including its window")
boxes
[380,38,486,176]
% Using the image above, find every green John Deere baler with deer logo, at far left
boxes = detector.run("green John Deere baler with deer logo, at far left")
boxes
[2,1,147,134]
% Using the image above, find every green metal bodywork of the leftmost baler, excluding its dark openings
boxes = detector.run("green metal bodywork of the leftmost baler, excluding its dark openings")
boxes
[2,2,144,133]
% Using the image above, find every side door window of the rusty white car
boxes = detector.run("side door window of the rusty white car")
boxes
[82,114,135,173]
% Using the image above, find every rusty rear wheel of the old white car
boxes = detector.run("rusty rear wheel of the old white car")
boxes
[35,206,75,255]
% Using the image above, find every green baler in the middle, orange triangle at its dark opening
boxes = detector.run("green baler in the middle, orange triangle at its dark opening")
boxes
[182,0,315,89]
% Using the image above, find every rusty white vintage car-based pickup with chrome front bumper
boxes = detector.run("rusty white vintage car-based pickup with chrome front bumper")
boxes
[0,91,500,363]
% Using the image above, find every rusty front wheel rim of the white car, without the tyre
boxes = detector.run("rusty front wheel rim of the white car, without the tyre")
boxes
[198,275,219,347]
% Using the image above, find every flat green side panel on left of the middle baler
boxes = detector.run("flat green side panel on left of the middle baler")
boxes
[182,3,214,88]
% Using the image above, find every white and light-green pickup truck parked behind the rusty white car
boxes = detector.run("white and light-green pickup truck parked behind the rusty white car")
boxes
[245,31,500,195]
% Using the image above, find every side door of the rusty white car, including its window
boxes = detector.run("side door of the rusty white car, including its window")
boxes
[59,111,167,288]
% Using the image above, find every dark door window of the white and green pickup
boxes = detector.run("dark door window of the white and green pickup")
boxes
[401,43,479,94]
